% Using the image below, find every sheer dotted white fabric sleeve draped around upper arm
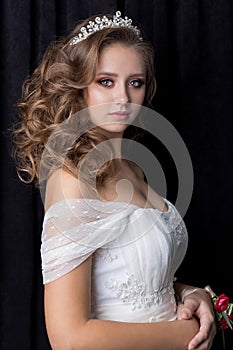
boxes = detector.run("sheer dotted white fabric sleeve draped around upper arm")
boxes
[41,199,132,284]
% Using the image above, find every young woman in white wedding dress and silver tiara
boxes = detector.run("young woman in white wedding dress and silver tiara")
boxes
[15,12,215,350]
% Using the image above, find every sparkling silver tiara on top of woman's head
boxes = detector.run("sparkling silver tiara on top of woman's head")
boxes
[70,11,141,45]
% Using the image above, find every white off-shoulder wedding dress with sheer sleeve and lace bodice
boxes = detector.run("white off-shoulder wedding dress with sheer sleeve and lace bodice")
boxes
[41,199,188,322]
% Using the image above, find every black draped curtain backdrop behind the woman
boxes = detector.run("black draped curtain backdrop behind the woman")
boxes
[0,0,233,350]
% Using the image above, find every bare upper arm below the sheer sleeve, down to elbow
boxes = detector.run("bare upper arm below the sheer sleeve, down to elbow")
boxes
[44,257,91,350]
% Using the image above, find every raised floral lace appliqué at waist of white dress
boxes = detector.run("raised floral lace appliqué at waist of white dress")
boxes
[105,273,175,310]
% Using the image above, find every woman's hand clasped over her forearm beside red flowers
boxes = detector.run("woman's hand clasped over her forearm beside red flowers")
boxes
[177,289,216,350]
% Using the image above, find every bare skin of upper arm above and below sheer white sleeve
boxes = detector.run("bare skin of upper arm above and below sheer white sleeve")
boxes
[44,169,91,350]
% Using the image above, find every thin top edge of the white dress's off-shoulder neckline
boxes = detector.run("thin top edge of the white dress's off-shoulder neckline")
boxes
[45,197,172,215]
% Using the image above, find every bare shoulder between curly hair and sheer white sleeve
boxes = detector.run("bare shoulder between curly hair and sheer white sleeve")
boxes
[45,169,82,211]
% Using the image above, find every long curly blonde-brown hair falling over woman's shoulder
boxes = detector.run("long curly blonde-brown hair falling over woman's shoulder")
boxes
[13,16,156,189]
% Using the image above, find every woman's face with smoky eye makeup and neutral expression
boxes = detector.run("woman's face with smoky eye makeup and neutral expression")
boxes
[86,44,146,134]
